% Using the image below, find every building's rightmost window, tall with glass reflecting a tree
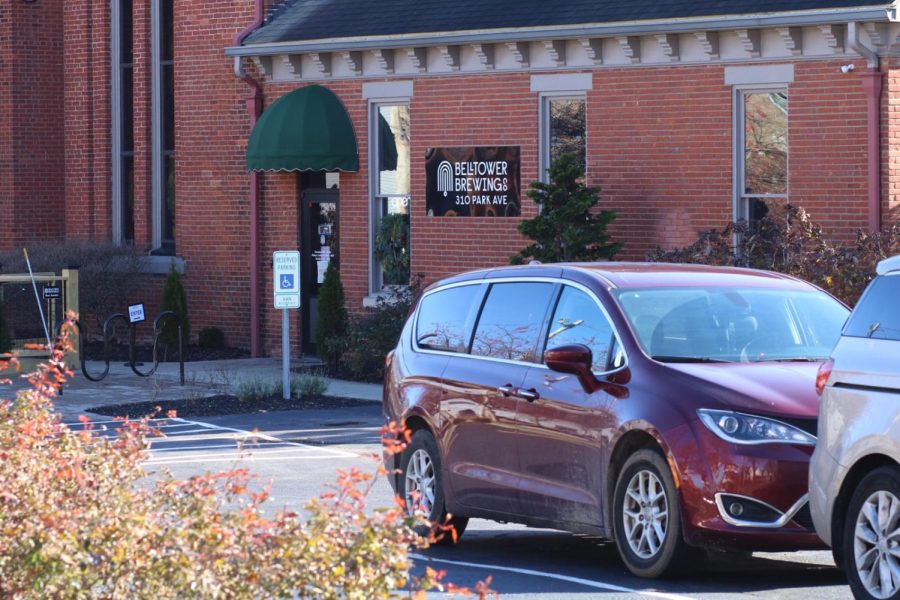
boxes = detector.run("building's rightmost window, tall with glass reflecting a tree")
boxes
[735,89,788,223]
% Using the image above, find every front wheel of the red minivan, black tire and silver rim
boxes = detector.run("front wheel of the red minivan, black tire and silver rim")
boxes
[613,450,693,578]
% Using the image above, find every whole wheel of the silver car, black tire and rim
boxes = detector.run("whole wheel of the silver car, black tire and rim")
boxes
[843,466,900,600]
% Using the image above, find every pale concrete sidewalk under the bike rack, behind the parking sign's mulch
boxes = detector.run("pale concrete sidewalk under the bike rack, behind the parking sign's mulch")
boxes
[0,358,381,421]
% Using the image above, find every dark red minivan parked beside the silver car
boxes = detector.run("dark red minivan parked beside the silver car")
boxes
[384,262,848,577]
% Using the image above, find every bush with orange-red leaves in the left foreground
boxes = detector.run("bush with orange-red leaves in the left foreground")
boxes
[0,315,493,599]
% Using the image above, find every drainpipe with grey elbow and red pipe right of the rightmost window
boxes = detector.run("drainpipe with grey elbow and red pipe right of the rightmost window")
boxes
[847,23,884,233]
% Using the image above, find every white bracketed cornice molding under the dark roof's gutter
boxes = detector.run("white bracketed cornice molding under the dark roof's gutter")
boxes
[250,23,900,82]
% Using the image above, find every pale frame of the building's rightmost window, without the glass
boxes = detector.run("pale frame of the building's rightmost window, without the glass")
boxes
[732,83,791,222]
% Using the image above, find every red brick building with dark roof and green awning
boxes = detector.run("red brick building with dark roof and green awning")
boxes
[0,0,900,353]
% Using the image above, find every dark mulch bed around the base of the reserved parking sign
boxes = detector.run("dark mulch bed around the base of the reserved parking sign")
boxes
[87,394,374,419]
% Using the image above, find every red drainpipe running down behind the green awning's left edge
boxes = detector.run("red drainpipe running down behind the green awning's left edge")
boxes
[232,0,265,358]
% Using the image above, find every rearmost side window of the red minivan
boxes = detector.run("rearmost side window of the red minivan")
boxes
[416,285,482,352]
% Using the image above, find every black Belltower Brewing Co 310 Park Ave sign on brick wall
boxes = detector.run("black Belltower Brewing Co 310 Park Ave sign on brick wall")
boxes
[425,146,520,217]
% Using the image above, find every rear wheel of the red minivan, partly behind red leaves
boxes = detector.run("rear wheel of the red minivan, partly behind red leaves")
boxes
[397,429,469,545]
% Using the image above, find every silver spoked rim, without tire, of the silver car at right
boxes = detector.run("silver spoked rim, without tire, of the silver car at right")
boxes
[853,490,900,598]
